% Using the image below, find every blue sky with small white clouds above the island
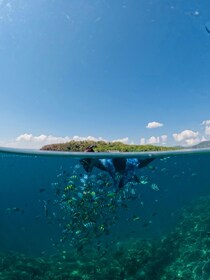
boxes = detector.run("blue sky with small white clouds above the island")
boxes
[0,0,210,148]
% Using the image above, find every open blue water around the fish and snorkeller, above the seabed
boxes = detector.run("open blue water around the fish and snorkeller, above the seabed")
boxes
[0,150,210,255]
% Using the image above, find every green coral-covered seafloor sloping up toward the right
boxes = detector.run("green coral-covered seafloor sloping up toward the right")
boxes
[0,197,210,280]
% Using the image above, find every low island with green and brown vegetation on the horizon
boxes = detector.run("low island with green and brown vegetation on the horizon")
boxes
[41,140,181,152]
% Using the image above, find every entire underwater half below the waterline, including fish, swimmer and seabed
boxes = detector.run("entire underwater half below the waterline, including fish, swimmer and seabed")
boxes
[0,149,210,280]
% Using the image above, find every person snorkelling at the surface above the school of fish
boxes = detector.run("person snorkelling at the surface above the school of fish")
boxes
[80,145,155,189]
